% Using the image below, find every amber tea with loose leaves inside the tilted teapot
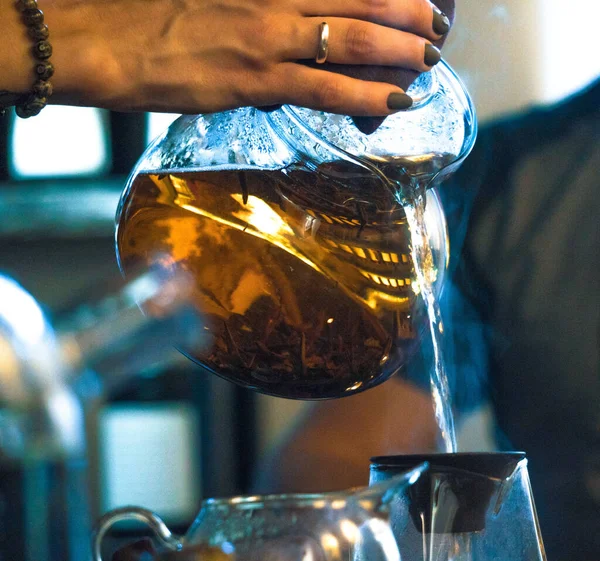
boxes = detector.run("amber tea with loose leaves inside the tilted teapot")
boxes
[117,170,427,399]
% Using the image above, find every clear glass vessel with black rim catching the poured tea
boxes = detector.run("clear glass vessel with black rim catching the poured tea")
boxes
[370,452,546,561]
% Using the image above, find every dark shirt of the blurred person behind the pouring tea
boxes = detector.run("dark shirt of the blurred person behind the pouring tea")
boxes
[441,82,600,561]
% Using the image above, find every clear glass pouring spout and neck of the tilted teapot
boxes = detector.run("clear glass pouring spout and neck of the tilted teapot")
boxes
[267,62,477,200]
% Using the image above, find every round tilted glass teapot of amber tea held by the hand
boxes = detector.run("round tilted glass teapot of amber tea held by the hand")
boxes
[116,62,476,399]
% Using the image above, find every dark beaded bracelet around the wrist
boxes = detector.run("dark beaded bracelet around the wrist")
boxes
[0,0,54,119]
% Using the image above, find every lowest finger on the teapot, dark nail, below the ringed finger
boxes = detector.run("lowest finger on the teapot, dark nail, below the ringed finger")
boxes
[268,62,412,116]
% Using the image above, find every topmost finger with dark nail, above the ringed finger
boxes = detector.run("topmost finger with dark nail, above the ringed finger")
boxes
[298,0,450,41]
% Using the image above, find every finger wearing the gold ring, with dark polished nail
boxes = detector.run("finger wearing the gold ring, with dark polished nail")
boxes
[285,18,441,71]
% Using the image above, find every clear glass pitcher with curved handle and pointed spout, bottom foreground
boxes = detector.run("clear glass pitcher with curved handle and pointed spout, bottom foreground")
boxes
[93,464,426,561]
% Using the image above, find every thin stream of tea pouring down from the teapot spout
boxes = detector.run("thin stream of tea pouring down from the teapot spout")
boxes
[404,190,457,453]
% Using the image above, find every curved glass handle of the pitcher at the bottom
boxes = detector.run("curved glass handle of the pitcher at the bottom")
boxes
[92,506,183,561]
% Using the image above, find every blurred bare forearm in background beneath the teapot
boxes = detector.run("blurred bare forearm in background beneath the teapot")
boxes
[255,380,438,492]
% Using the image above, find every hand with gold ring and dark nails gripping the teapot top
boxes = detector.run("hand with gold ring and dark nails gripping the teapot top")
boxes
[0,0,450,116]
